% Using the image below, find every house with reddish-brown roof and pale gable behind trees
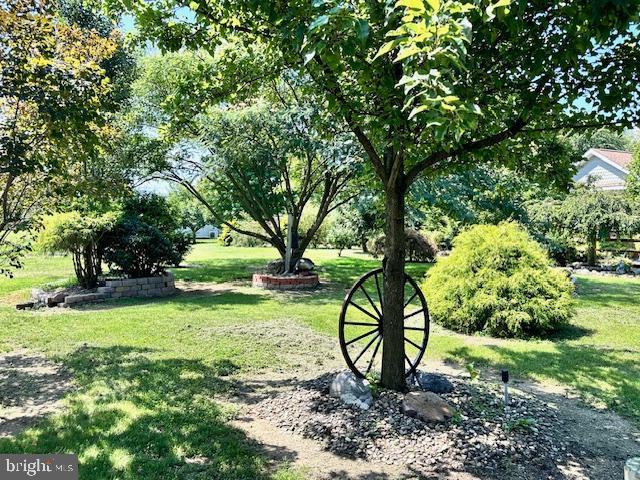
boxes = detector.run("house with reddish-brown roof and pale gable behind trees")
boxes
[573,148,632,190]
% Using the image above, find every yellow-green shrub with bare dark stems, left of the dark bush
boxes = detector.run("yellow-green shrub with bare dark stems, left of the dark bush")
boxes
[38,211,117,288]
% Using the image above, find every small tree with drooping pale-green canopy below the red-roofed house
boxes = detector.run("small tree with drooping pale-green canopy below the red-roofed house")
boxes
[529,187,640,265]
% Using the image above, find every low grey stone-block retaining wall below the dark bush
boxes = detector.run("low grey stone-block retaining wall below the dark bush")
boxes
[61,272,176,307]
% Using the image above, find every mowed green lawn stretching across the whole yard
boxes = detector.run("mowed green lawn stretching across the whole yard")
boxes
[0,242,640,479]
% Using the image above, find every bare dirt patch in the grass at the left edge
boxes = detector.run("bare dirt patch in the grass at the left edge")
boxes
[0,350,72,437]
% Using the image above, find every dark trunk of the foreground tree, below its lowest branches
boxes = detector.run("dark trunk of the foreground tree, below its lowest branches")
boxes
[381,179,406,391]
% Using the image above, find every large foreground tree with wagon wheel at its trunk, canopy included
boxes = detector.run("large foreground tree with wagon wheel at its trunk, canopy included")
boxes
[117,0,640,390]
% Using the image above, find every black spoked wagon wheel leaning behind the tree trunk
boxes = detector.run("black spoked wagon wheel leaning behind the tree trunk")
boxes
[339,268,429,378]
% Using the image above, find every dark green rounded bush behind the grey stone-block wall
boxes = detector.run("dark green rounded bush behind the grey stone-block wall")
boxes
[103,217,182,278]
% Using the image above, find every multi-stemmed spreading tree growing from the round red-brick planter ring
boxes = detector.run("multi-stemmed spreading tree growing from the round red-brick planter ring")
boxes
[132,54,362,268]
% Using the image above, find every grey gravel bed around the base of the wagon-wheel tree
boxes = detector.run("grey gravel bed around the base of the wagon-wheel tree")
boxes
[253,374,578,479]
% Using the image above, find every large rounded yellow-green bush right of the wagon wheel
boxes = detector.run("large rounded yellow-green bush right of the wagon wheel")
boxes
[423,223,574,337]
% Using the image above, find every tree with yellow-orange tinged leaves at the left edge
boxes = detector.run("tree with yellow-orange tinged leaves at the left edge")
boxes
[0,0,117,267]
